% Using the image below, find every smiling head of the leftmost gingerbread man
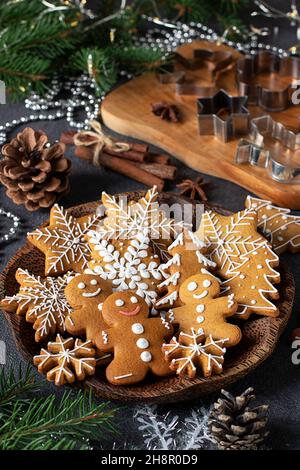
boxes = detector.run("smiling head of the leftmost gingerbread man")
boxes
[65,274,111,308]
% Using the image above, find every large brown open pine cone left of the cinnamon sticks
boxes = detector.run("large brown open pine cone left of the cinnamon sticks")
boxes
[0,127,71,211]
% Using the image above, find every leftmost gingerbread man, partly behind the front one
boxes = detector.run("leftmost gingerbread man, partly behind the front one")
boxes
[65,274,112,344]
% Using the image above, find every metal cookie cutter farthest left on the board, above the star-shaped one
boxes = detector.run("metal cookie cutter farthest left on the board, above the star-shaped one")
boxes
[156,49,235,96]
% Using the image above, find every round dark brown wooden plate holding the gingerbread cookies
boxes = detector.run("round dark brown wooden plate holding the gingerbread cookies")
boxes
[0,192,295,403]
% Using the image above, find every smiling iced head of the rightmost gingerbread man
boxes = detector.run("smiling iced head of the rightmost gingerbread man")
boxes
[179,274,220,304]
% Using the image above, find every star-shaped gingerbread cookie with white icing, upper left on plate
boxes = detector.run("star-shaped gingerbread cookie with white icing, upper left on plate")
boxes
[28,204,100,275]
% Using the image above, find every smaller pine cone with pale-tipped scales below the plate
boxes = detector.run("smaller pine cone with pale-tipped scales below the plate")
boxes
[209,388,269,450]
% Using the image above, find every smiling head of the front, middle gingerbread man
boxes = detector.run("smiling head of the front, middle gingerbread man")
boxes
[102,290,149,329]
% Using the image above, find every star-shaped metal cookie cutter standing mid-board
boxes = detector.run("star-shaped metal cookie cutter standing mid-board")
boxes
[197,90,250,142]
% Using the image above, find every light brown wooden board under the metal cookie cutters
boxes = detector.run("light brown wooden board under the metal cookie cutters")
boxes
[101,41,300,209]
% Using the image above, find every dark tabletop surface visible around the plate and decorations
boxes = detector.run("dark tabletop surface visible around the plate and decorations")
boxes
[0,1,300,449]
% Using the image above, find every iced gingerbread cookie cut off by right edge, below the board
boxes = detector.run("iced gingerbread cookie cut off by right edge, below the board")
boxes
[245,196,300,254]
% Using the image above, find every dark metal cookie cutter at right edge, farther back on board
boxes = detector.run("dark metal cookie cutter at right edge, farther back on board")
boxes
[237,51,300,111]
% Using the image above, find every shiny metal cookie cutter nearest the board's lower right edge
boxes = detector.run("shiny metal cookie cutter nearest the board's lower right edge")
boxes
[235,116,300,184]
